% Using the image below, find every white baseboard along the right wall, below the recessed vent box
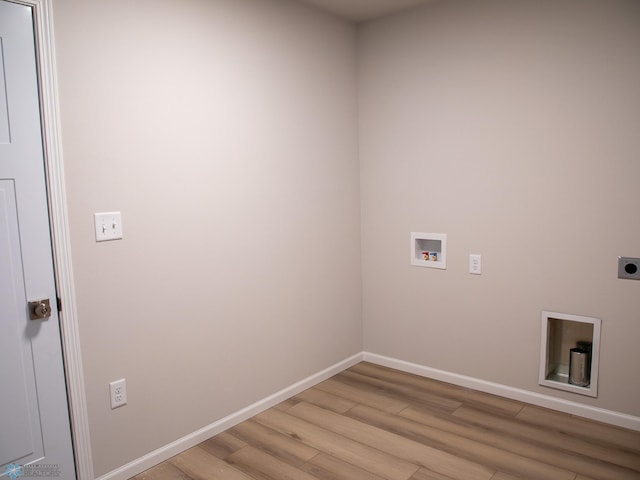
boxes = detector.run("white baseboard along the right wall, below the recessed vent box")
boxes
[362,352,640,431]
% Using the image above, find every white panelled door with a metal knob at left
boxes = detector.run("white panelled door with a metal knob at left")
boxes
[0,0,76,480]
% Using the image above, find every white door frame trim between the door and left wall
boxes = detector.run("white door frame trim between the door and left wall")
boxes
[8,0,94,480]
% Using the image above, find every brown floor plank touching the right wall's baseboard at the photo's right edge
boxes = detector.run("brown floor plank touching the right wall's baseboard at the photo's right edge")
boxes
[517,405,640,454]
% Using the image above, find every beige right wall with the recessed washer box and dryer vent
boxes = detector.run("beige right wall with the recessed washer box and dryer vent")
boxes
[359,0,640,416]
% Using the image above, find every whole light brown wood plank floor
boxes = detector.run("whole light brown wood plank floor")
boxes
[134,363,640,480]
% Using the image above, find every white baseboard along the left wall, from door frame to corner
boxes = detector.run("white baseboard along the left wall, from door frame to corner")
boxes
[97,353,363,480]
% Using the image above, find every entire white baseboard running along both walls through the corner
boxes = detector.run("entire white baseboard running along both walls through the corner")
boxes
[96,352,640,480]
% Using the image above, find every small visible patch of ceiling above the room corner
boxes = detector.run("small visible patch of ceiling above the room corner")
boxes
[301,0,434,22]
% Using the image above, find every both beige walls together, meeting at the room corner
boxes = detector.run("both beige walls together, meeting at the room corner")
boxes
[54,0,640,475]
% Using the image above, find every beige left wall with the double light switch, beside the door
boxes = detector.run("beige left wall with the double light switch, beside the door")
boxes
[54,0,362,476]
